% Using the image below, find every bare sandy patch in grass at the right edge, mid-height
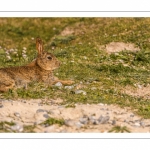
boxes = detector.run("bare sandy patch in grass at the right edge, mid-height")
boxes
[124,85,150,99]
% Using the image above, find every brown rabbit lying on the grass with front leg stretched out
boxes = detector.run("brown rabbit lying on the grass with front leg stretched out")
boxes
[0,38,73,92]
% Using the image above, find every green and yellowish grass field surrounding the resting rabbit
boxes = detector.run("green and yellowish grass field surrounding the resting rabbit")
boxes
[0,18,150,118]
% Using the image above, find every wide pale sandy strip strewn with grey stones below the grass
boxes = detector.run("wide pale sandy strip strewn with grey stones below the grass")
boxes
[0,99,150,133]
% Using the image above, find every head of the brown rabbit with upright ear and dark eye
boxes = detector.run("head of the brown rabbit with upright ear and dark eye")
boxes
[36,38,60,71]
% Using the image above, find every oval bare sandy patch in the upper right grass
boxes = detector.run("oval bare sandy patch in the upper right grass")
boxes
[99,42,140,53]
